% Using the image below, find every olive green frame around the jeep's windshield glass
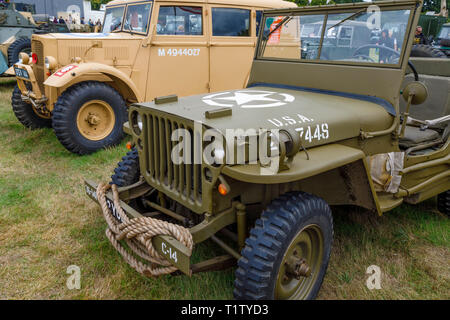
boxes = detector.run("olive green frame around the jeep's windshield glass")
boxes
[254,1,417,69]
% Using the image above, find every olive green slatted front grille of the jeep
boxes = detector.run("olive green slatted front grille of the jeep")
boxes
[140,113,202,211]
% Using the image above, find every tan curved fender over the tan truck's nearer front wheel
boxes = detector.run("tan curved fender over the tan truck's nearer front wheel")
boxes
[44,63,143,101]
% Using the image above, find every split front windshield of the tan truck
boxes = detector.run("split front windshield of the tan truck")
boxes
[103,2,152,34]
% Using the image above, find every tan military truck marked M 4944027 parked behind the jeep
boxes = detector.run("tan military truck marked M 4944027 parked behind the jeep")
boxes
[8,0,295,154]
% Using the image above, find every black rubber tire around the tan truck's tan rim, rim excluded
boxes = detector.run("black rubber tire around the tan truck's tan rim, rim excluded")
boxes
[52,81,128,155]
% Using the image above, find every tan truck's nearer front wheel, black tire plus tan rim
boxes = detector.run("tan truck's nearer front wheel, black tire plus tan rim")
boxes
[52,82,127,155]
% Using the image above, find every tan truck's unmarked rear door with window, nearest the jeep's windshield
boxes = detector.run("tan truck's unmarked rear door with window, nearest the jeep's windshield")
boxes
[210,5,256,92]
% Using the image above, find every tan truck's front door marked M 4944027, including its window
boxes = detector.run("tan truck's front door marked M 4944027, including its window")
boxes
[146,2,209,100]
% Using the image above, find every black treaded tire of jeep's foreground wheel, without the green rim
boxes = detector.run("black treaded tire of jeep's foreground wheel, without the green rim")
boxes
[233,192,333,300]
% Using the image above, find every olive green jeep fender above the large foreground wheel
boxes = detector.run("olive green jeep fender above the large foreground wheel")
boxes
[222,144,381,215]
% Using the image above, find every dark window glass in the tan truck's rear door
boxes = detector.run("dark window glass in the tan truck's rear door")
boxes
[212,8,250,37]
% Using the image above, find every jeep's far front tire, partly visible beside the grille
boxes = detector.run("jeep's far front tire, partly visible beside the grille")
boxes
[111,148,141,187]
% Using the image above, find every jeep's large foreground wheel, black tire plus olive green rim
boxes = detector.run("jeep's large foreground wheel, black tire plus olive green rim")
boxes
[234,192,333,300]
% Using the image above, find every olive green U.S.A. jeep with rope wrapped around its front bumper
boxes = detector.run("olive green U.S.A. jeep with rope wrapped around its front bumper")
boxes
[86,0,450,299]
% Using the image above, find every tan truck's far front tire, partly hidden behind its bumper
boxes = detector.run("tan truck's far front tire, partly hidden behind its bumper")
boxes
[11,84,52,130]
